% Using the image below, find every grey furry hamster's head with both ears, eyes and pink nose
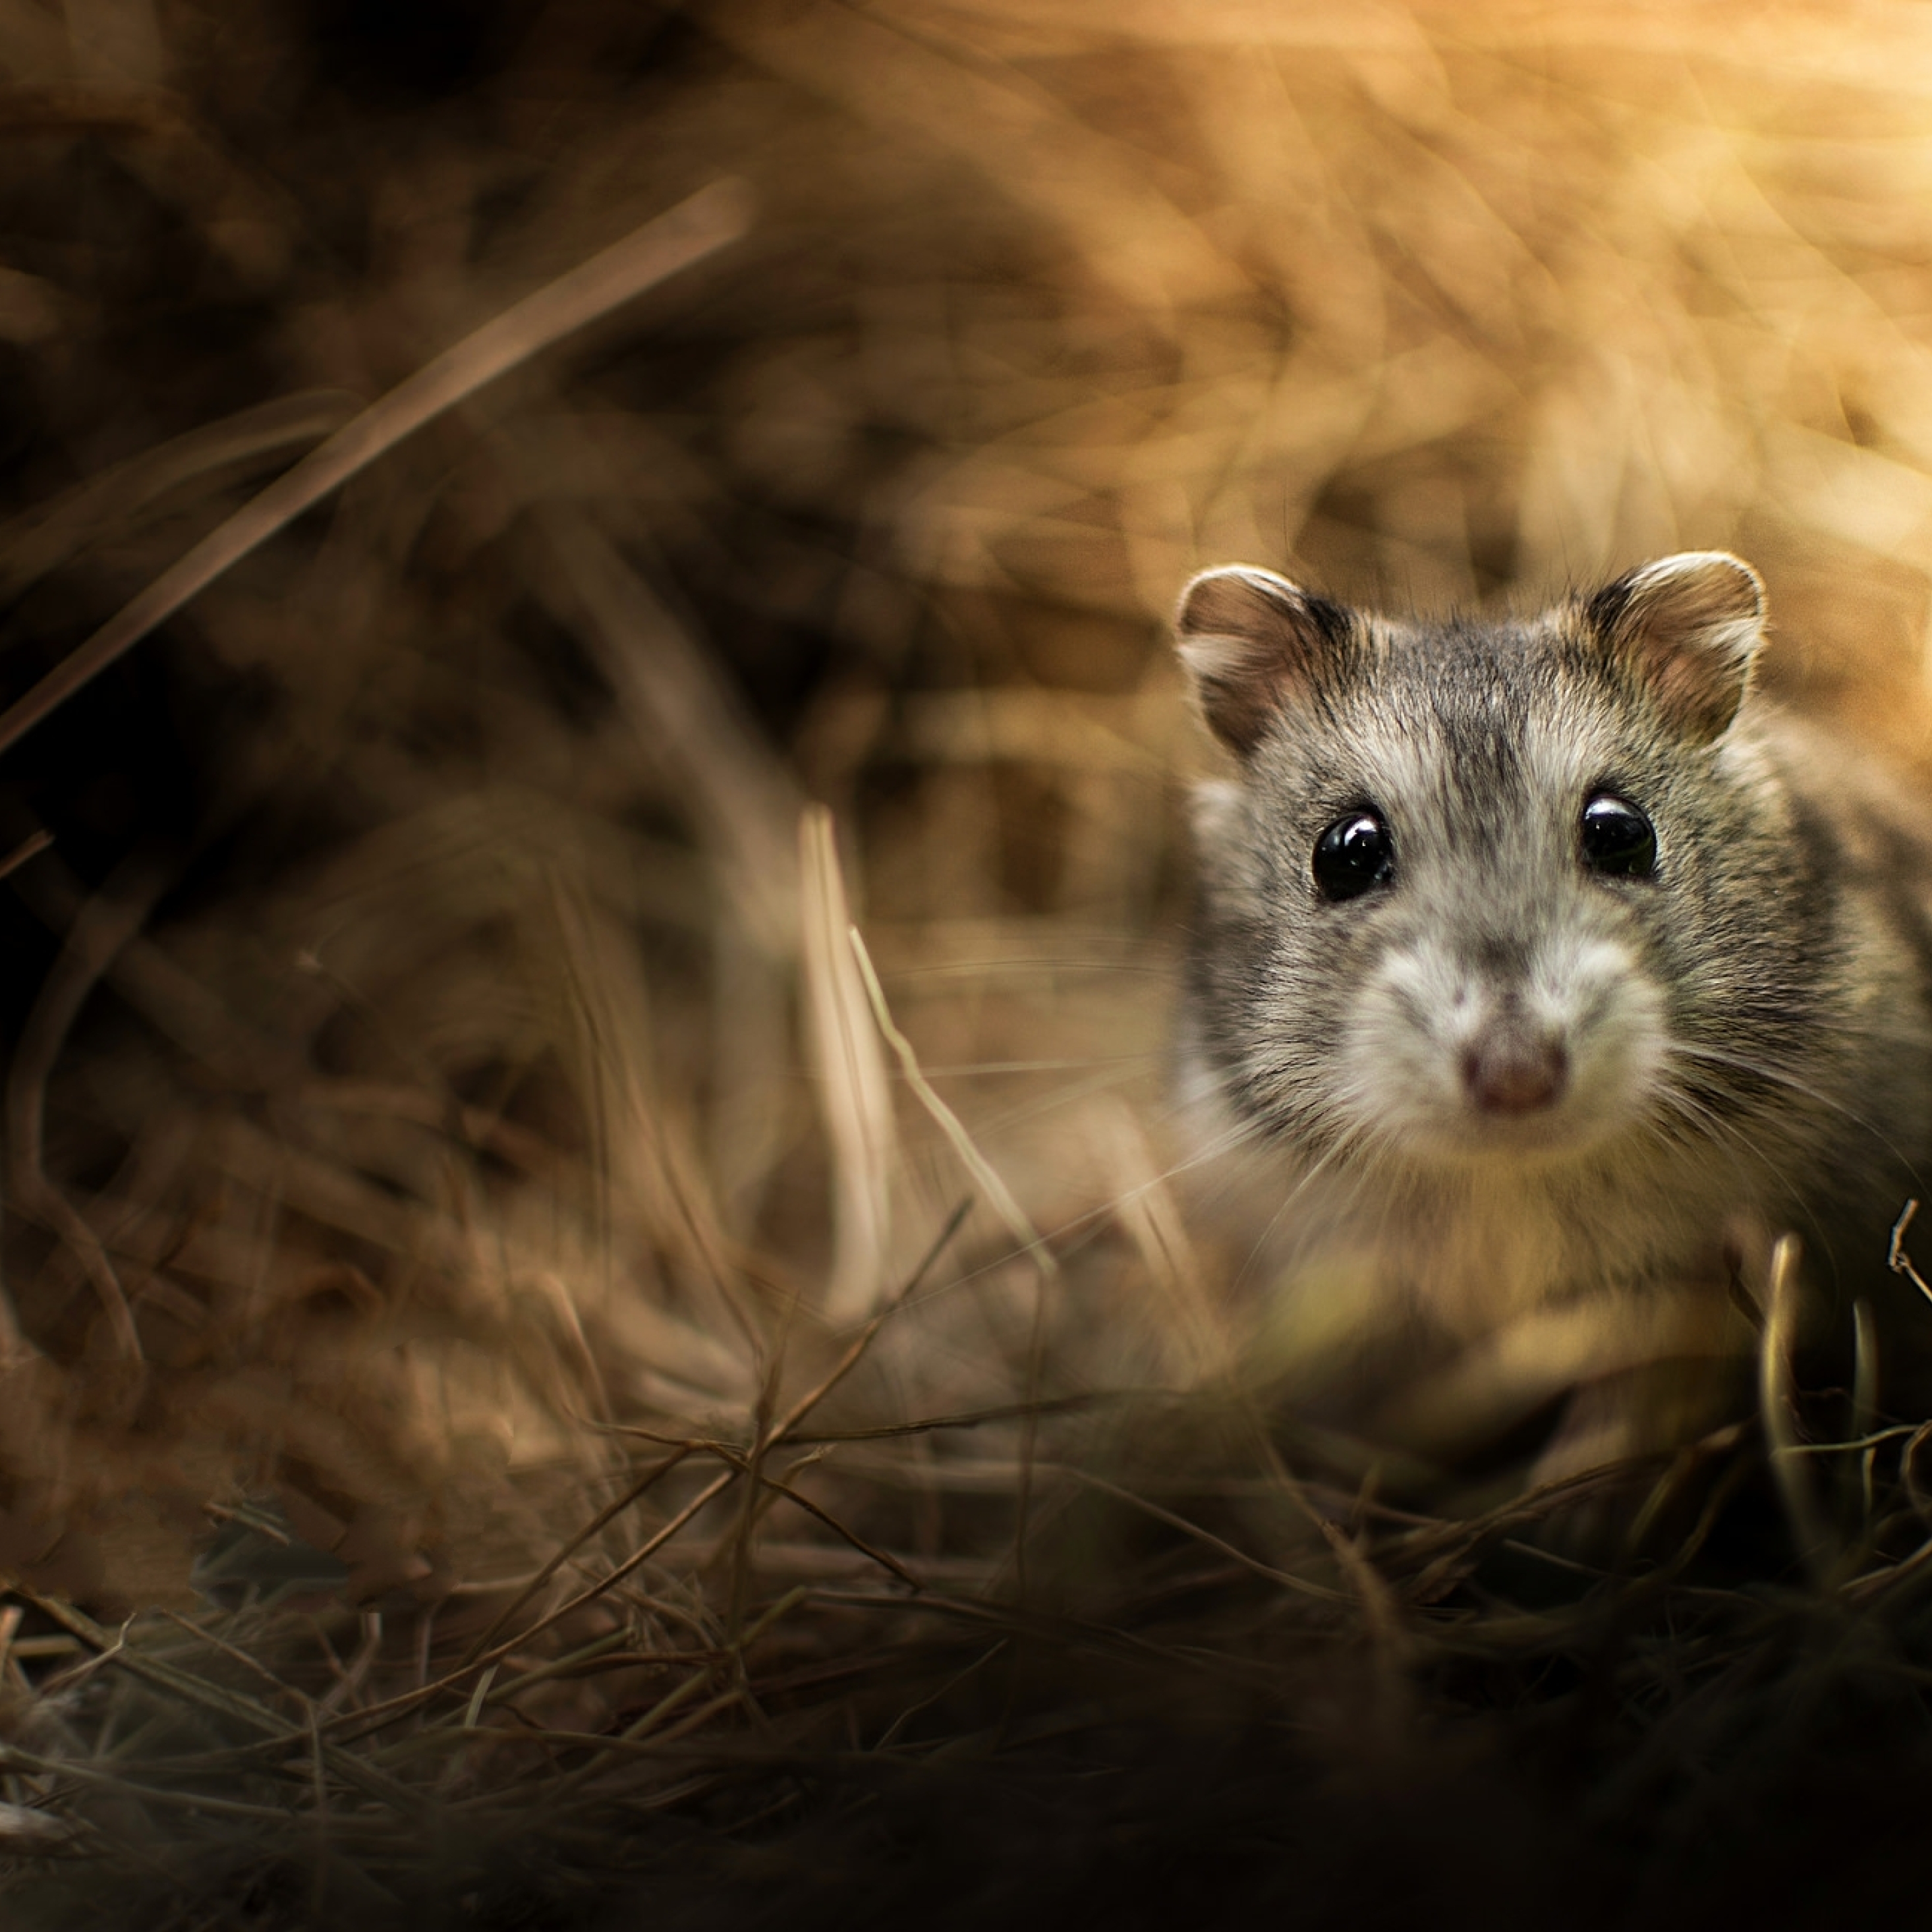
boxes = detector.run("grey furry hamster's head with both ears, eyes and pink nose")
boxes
[1179,553,1799,1169]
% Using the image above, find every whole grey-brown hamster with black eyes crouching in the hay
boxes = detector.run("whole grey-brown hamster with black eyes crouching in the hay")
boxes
[1177,551,1932,1474]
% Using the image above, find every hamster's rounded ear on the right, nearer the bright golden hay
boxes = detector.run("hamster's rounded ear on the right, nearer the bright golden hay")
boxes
[1582,551,1764,744]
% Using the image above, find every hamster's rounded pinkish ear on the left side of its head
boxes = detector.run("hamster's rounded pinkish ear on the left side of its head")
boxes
[1175,564,1356,757]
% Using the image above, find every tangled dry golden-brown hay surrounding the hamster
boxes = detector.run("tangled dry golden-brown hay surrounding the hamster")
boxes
[0,0,1932,1928]
